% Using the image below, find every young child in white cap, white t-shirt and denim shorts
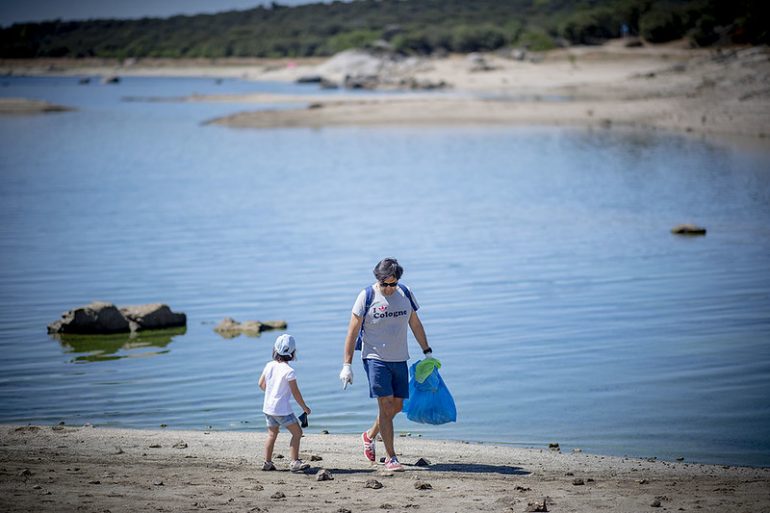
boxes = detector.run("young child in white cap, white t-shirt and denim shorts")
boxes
[259,333,310,472]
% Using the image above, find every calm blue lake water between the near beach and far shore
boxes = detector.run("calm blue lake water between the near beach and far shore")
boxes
[0,77,770,466]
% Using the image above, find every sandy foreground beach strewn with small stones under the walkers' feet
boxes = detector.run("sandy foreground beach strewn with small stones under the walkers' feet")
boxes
[0,425,770,513]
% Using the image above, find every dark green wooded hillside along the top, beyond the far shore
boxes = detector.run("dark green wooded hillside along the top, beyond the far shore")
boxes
[0,0,768,58]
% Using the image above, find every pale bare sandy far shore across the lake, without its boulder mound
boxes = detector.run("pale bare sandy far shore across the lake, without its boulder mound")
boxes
[0,41,770,139]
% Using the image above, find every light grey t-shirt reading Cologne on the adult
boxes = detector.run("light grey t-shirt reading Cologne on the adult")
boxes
[353,286,420,362]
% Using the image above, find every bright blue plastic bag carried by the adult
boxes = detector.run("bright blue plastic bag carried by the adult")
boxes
[402,361,457,424]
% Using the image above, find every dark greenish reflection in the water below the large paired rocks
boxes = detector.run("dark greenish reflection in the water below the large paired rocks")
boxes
[52,327,187,363]
